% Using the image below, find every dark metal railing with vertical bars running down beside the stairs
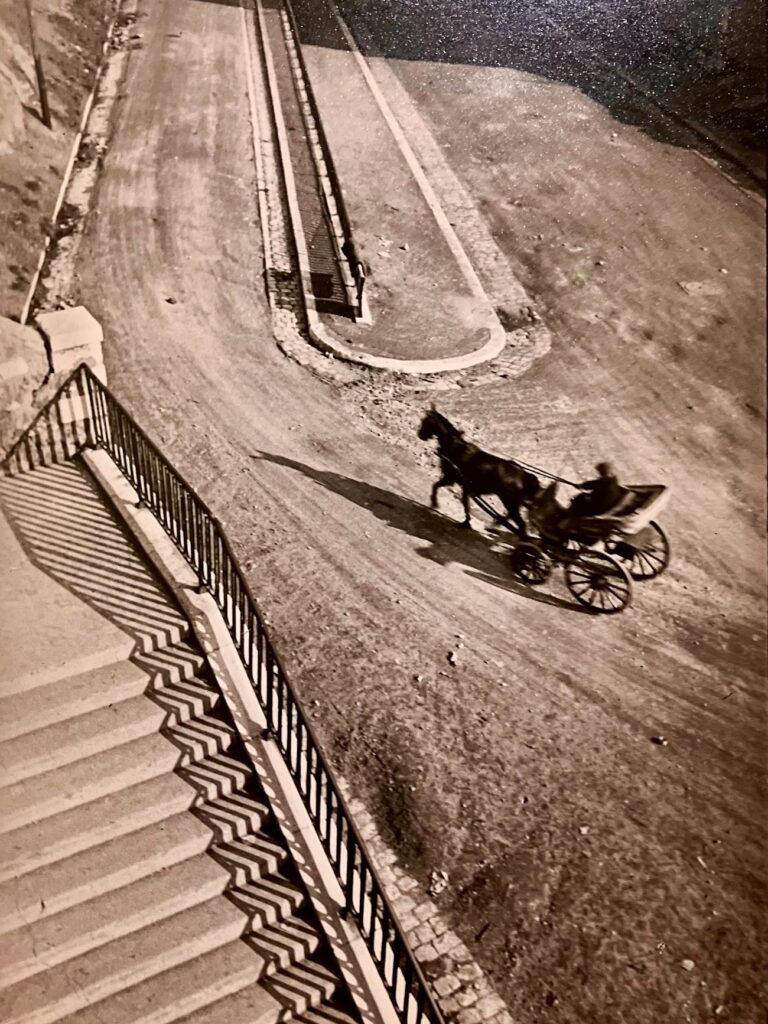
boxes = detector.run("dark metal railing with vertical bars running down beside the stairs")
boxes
[0,364,443,1024]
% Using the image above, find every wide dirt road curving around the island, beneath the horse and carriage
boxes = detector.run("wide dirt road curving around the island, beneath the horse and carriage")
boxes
[70,0,768,1024]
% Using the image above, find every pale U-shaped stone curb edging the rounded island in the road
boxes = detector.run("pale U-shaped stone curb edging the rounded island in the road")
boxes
[249,0,507,375]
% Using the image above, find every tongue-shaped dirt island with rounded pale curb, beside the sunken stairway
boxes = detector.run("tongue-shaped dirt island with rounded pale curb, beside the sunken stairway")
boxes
[292,0,506,373]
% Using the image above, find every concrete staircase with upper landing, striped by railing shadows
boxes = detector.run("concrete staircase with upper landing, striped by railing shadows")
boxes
[0,463,358,1024]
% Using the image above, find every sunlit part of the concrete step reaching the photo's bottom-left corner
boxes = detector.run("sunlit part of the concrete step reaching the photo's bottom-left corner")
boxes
[0,896,247,1024]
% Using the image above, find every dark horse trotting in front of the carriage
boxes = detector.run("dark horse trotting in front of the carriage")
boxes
[419,407,542,537]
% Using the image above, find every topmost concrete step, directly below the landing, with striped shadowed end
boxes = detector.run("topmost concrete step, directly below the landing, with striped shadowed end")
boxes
[0,643,205,742]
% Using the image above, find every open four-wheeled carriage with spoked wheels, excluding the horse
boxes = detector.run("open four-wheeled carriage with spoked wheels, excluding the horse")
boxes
[505,481,670,614]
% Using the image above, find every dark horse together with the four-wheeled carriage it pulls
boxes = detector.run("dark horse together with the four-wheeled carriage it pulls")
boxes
[419,409,670,614]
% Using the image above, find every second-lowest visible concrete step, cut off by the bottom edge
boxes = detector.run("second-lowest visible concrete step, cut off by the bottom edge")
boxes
[174,957,342,1024]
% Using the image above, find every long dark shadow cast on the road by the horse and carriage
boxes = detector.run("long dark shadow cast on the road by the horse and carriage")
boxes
[251,450,589,613]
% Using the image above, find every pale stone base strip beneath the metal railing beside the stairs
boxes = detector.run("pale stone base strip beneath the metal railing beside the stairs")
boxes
[81,450,400,1024]
